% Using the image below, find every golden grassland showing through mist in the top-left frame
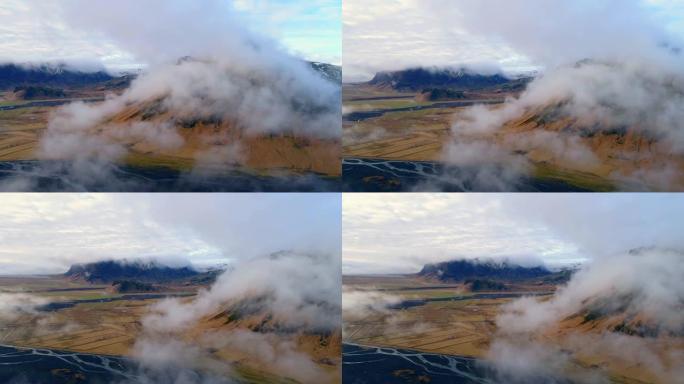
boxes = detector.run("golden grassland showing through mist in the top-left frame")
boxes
[0,95,341,177]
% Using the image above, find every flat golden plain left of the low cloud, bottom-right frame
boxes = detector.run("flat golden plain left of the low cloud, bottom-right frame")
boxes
[344,276,510,357]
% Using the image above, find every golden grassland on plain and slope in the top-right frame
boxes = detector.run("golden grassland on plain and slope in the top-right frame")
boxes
[342,84,684,192]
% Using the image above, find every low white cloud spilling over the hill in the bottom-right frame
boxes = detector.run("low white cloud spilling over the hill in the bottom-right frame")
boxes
[488,248,684,383]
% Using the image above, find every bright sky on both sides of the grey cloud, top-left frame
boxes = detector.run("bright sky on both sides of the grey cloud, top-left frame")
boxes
[0,0,342,71]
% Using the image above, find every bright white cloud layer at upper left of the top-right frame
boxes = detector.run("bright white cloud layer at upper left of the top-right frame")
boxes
[342,0,530,81]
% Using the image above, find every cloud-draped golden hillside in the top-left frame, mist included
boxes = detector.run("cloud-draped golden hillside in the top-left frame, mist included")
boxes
[32,58,341,177]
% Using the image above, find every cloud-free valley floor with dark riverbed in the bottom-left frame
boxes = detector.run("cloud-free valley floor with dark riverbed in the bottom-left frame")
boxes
[0,277,337,384]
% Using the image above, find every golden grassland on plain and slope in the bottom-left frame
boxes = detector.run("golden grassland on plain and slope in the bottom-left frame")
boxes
[0,276,341,384]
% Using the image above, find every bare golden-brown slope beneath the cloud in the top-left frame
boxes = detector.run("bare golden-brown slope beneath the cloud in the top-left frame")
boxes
[101,99,341,176]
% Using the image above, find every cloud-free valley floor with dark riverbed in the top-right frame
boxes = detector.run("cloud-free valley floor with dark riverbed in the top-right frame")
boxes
[343,84,680,192]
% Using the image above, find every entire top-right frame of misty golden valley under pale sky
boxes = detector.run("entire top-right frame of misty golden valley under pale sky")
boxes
[344,0,684,191]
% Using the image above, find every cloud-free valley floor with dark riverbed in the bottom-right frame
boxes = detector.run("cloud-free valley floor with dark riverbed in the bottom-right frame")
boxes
[343,276,681,384]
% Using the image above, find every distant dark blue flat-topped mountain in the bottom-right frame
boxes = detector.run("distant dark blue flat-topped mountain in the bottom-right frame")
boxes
[418,259,553,282]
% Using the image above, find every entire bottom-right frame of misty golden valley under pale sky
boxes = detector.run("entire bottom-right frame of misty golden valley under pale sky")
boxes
[343,194,684,383]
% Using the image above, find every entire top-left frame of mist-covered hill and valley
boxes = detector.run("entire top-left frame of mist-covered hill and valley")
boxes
[0,0,341,191]
